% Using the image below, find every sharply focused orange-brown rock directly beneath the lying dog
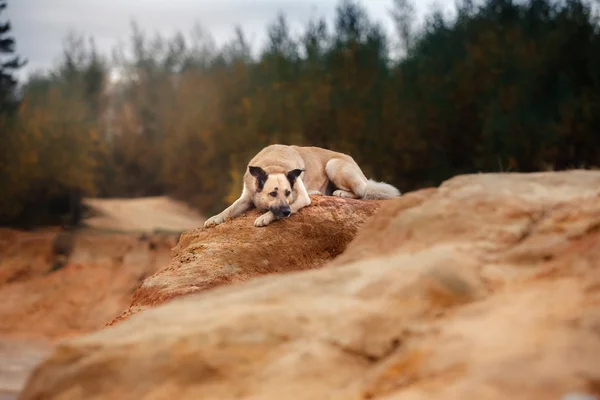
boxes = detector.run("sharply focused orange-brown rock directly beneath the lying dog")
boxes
[110,196,380,325]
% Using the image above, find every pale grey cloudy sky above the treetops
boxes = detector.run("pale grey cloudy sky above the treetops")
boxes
[0,0,454,76]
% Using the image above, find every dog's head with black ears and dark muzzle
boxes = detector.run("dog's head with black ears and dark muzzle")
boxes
[248,166,304,218]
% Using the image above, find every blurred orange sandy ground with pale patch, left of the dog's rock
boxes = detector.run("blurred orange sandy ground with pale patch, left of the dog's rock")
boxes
[0,197,204,400]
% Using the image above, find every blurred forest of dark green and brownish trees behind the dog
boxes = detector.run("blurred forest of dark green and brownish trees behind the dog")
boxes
[0,0,600,225]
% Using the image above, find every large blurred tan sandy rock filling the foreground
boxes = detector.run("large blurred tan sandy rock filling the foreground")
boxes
[20,171,600,400]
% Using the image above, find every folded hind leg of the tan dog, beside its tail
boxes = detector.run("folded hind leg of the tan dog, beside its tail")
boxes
[325,158,368,199]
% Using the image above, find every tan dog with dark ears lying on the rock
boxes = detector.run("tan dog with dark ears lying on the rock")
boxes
[204,144,401,228]
